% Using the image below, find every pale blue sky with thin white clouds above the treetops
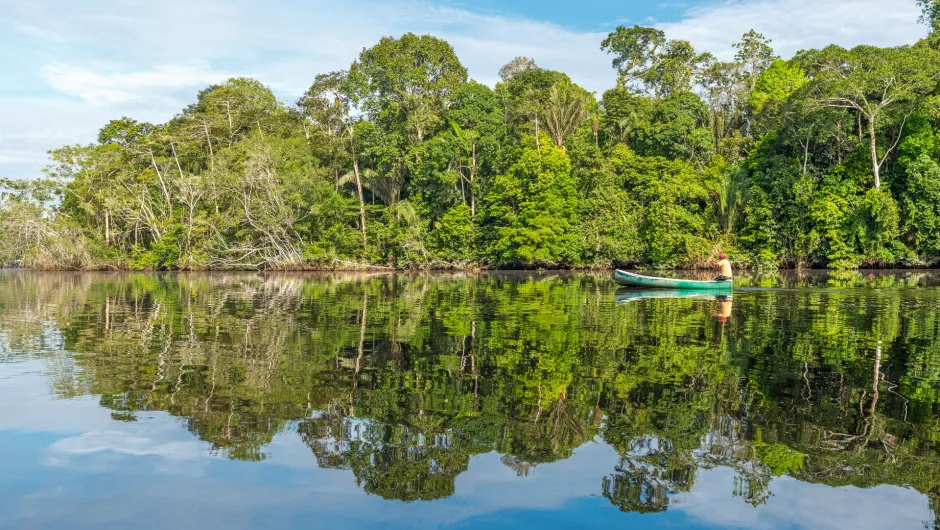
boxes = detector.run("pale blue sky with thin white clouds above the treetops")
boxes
[0,0,926,178]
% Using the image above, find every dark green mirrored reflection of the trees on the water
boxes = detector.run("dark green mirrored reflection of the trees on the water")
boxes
[0,272,940,524]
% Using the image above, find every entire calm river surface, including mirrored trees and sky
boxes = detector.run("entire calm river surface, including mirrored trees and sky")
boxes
[0,272,940,529]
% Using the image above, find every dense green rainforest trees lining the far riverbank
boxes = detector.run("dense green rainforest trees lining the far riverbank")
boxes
[0,7,940,271]
